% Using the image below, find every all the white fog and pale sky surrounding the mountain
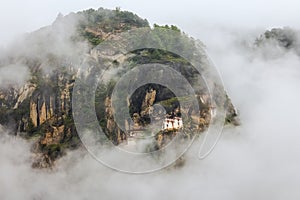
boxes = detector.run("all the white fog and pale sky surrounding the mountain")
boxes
[0,0,300,200]
